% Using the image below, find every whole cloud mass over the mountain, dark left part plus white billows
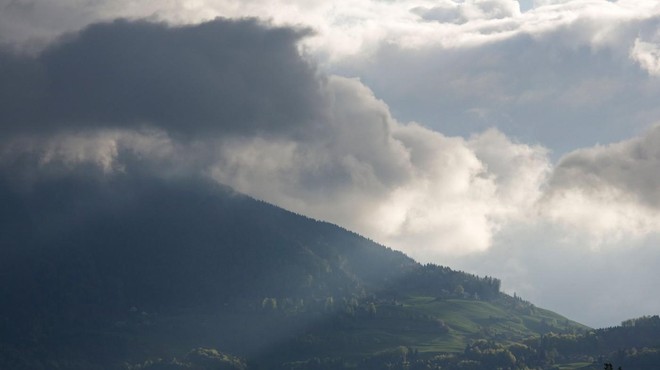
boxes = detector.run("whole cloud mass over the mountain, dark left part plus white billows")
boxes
[0,19,549,259]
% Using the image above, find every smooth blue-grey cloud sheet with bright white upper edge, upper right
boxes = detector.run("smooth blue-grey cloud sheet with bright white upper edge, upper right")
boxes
[333,1,660,155]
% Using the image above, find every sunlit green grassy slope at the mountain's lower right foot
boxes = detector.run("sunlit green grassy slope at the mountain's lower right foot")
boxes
[270,296,587,360]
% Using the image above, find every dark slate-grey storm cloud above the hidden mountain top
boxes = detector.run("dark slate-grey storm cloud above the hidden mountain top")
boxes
[0,19,319,136]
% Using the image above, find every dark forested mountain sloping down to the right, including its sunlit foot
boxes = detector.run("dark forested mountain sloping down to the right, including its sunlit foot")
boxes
[0,173,588,369]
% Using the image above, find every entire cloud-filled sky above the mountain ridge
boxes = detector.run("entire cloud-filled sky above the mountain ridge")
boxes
[0,0,660,327]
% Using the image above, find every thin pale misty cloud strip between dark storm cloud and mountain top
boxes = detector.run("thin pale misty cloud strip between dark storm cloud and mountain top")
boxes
[0,129,188,181]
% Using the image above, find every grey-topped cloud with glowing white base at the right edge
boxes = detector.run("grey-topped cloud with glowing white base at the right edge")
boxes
[541,126,660,245]
